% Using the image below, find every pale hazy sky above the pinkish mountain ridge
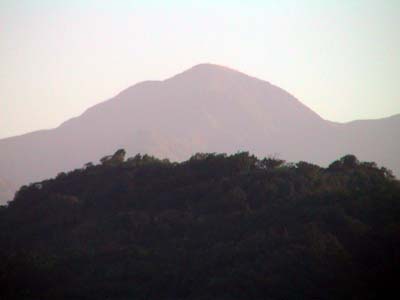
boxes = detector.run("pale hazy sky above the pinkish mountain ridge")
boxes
[0,0,400,138]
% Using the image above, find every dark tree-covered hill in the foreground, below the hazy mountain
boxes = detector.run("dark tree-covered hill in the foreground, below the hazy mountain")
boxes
[0,150,400,300]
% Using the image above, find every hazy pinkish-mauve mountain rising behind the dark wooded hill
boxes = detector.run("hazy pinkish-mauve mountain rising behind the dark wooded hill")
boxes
[0,64,400,201]
